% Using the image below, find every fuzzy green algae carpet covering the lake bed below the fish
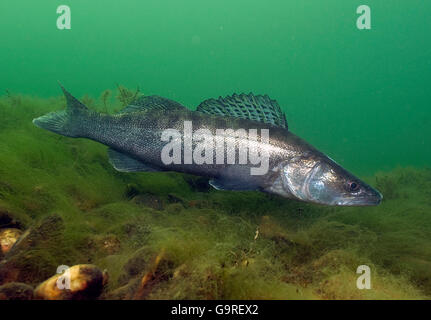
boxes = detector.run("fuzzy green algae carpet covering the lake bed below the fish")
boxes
[0,90,431,299]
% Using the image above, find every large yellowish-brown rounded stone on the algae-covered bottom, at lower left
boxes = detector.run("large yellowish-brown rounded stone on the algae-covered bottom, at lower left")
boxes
[34,264,107,300]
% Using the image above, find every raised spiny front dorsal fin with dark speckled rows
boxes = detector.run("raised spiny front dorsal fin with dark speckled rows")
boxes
[196,93,287,129]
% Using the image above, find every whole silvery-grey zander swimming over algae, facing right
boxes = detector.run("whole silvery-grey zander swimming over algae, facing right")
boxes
[33,87,382,206]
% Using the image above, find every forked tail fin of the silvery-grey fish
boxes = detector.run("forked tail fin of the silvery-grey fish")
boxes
[33,83,88,137]
